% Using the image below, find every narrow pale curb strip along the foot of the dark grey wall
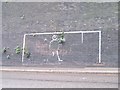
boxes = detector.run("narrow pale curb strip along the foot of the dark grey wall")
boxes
[0,68,119,74]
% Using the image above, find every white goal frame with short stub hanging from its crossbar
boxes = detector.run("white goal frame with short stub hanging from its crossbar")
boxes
[22,31,102,64]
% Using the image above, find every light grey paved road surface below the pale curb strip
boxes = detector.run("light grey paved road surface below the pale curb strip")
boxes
[1,71,118,88]
